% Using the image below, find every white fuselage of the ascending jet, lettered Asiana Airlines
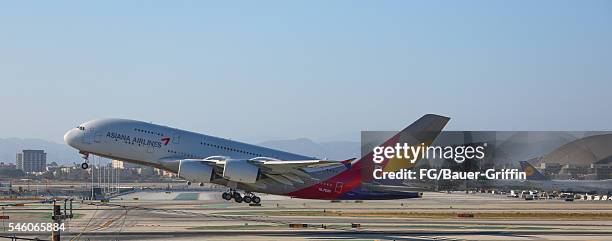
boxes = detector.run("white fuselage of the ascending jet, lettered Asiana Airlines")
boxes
[64,119,314,172]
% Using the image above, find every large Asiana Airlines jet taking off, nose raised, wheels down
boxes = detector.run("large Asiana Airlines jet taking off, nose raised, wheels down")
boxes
[64,114,449,203]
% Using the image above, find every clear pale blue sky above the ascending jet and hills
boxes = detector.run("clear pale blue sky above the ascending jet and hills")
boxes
[0,1,612,142]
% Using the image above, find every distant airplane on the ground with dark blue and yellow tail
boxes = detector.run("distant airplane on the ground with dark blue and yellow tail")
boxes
[520,161,612,194]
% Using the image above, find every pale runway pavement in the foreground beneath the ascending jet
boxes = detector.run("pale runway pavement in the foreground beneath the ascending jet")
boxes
[3,190,612,240]
